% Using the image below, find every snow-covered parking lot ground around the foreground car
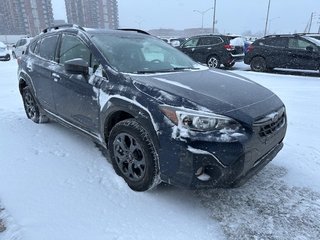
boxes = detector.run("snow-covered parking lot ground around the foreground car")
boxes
[0,60,320,240]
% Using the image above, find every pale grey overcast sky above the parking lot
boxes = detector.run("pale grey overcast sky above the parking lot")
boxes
[52,0,320,34]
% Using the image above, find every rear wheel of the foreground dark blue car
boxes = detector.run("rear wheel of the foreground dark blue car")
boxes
[22,86,49,123]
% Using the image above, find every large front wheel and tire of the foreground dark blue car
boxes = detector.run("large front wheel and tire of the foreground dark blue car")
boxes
[108,119,160,191]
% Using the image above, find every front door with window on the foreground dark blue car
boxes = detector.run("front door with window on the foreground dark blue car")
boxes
[52,34,100,133]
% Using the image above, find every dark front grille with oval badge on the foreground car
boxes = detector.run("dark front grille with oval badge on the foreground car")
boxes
[253,108,286,138]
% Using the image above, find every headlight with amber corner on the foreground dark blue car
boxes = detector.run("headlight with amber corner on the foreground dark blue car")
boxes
[160,106,240,132]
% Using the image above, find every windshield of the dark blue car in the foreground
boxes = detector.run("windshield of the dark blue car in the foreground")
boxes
[92,33,199,73]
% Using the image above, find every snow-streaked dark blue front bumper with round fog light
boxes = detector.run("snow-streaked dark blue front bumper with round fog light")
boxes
[159,115,286,189]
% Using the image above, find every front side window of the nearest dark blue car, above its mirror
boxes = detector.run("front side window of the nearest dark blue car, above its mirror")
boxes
[58,35,91,65]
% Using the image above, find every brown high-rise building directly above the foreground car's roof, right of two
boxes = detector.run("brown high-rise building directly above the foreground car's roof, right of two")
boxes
[65,0,119,29]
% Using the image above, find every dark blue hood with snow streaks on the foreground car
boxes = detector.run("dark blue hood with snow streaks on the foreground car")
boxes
[131,70,283,123]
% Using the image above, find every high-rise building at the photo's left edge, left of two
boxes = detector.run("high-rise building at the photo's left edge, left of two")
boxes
[0,0,53,36]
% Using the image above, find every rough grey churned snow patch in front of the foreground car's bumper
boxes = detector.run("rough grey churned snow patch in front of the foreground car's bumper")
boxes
[195,164,320,240]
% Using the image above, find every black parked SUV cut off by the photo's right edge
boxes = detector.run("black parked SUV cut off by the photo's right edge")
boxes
[244,34,320,72]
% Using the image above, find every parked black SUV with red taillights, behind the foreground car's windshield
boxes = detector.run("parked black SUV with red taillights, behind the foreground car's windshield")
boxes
[178,35,244,68]
